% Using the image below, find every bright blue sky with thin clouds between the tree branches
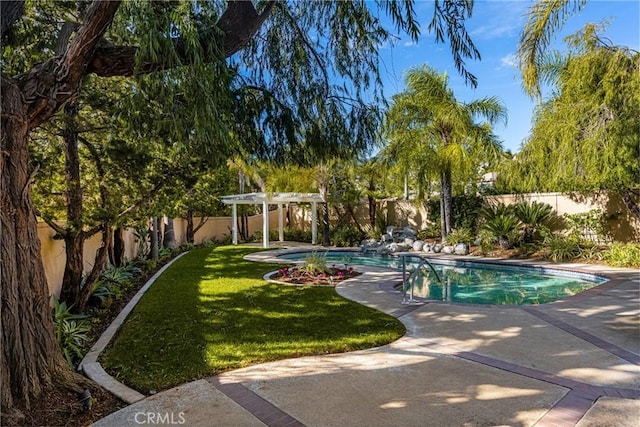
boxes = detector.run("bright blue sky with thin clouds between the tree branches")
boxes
[380,0,640,153]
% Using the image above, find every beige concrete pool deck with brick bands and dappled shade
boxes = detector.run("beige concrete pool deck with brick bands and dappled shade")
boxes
[94,252,640,427]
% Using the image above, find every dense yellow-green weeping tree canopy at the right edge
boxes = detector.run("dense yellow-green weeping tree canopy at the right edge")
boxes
[500,25,640,215]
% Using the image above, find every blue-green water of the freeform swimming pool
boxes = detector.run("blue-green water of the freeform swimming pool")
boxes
[280,251,607,305]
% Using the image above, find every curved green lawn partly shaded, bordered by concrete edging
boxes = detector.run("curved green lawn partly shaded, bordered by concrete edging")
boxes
[101,246,405,393]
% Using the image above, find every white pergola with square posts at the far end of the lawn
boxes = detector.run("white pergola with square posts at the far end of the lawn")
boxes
[222,193,323,248]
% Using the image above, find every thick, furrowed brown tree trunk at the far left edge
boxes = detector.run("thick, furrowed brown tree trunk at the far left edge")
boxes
[0,115,84,423]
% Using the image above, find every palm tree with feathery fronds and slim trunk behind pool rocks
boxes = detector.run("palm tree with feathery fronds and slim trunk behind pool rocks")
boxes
[385,65,507,239]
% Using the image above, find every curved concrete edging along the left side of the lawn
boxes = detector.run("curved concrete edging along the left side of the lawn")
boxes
[78,252,187,404]
